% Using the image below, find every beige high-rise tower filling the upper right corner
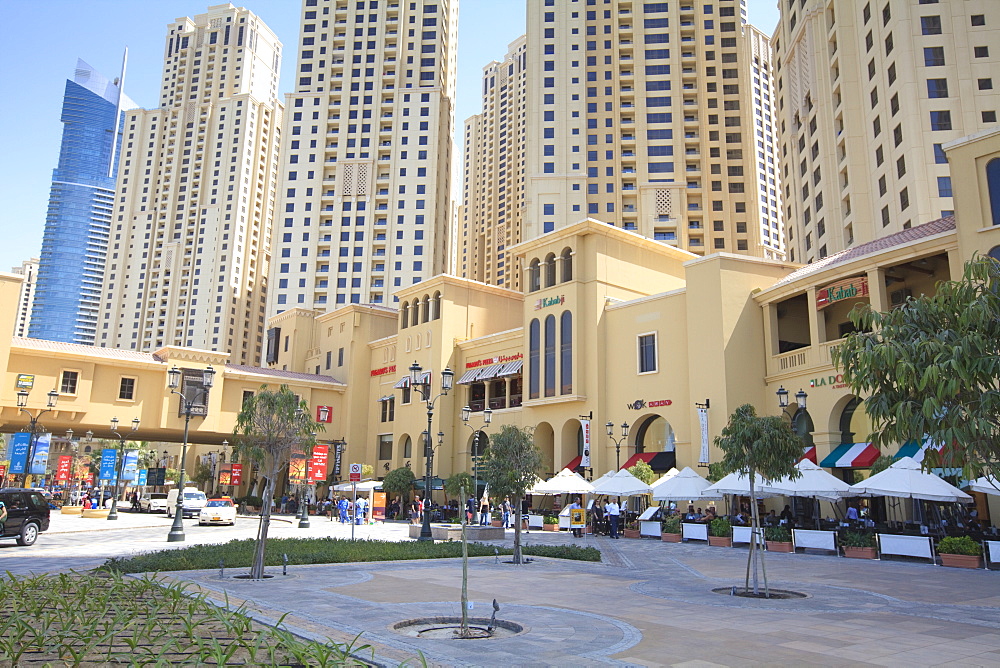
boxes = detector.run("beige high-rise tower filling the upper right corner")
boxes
[772,0,1000,263]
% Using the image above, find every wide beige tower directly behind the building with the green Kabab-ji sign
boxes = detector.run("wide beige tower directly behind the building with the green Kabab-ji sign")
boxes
[508,0,783,260]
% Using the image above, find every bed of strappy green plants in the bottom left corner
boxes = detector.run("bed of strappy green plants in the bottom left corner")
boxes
[0,572,374,666]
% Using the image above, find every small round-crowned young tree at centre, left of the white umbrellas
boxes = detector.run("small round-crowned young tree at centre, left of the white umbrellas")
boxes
[482,425,542,564]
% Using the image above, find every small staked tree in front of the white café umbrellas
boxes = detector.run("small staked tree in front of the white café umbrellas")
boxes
[715,404,802,597]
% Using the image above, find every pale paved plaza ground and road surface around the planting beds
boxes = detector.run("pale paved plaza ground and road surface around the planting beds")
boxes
[0,514,1000,666]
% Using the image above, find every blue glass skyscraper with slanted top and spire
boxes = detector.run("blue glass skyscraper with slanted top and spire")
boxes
[28,60,137,345]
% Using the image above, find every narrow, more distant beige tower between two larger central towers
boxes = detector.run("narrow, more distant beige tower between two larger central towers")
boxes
[456,37,527,290]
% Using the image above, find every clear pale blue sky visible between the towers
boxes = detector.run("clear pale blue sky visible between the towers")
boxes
[0,0,778,271]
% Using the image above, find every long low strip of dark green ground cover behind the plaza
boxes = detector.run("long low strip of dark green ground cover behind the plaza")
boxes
[100,538,601,573]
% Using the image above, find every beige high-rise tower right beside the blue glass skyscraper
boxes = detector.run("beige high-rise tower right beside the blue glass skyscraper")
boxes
[98,4,281,364]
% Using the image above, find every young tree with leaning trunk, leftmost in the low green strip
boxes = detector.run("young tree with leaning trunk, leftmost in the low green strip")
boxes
[233,385,323,579]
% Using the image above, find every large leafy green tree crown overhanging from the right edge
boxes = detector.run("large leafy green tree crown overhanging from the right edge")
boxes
[833,256,1000,480]
